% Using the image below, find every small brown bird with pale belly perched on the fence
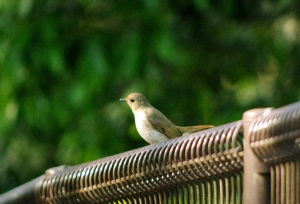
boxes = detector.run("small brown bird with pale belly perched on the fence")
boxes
[120,93,214,144]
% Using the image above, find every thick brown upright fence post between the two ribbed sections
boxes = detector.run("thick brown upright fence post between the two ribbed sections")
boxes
[243,108,270,204]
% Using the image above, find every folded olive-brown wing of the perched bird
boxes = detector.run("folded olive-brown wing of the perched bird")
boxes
[146,108,182,139]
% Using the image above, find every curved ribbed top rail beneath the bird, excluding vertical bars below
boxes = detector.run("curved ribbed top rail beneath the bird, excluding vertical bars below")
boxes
[35,121,243,203]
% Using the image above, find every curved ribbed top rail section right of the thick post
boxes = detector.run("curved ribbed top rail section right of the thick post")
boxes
[249,102,300,165]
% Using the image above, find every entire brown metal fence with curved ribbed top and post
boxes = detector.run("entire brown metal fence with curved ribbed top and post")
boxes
[0,102,300,204]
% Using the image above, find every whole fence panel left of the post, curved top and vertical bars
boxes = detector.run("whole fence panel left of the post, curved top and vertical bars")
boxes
[35,121,243,203]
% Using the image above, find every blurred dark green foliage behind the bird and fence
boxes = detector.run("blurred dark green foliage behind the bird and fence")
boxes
[0,0,300,193]
